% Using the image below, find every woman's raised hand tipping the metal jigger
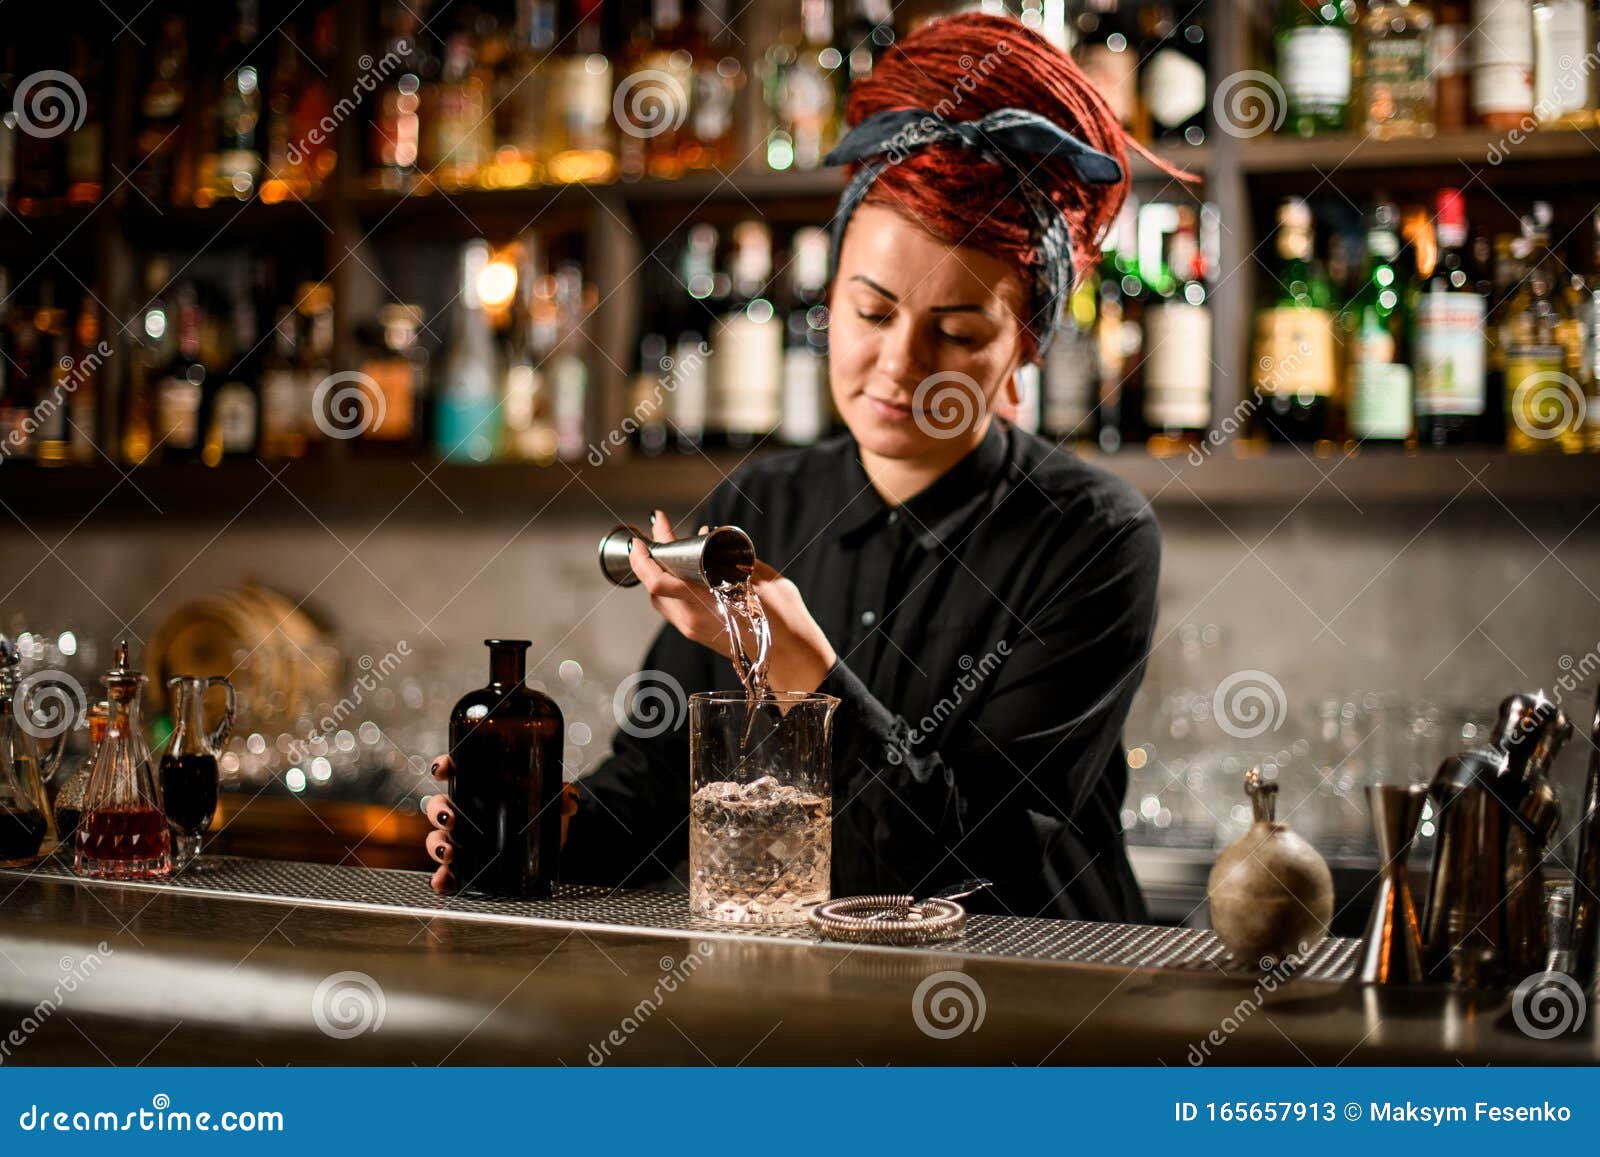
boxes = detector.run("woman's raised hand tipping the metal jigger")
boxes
[629,510,838,691]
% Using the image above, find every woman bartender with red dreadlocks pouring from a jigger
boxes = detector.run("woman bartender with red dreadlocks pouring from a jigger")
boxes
[427,14,1160,920]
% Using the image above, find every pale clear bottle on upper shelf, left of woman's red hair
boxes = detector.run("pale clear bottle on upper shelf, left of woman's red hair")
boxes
[765,0,845,170]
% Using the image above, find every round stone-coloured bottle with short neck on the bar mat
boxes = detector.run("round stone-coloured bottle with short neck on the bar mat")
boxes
[1206,768,1333,968]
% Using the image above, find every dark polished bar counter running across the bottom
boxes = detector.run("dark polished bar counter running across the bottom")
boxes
[0,859,1600,1066]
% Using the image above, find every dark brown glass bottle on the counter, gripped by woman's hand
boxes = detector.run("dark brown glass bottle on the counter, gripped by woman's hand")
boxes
[450,639,562,898]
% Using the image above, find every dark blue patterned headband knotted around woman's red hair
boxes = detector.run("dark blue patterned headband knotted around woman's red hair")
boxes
[822,109,1122,355]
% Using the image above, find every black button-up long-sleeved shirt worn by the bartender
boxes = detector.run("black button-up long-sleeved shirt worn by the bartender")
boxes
[562,418,1160,920]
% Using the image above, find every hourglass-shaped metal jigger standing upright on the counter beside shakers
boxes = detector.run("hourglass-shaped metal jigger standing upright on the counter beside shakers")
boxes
[1358,784,1427,984]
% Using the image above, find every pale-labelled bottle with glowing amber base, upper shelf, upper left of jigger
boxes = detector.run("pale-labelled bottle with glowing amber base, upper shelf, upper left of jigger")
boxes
[546,0,618,184]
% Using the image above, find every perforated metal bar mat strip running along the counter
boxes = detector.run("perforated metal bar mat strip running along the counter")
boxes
[0,856,1360,981]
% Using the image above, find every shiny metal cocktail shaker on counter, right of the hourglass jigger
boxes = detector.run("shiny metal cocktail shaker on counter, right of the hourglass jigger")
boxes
[1422,693,1573,987]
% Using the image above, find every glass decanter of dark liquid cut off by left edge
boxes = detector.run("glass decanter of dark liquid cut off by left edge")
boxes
[0,635,68,867]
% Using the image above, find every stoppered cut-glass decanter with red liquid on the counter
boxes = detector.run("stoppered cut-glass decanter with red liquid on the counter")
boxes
[72,640,173,880]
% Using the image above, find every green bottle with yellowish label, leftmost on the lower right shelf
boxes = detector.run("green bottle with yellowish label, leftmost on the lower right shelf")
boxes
[1254,197,1338,442]
